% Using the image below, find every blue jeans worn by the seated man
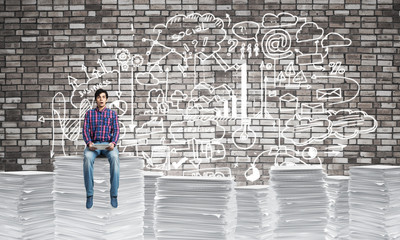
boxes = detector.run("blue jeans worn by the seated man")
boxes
[83,143,119,196]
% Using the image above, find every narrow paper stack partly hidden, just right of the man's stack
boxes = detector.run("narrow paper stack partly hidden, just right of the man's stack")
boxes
[144,172,163,240]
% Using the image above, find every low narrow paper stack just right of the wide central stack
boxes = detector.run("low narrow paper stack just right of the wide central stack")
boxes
[235,185,271,240]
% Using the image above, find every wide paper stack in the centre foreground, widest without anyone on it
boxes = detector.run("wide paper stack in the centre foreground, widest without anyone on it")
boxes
[154,176,237,240]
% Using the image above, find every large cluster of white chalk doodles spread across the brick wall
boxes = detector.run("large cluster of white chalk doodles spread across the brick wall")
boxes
[43,12,377,182]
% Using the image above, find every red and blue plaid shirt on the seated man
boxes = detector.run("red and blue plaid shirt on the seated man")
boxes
[82,107,119,145]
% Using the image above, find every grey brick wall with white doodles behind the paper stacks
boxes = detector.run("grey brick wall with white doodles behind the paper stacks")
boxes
[0,0,400,184]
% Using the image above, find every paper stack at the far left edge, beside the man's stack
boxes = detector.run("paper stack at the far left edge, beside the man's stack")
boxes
[0,171,54,240]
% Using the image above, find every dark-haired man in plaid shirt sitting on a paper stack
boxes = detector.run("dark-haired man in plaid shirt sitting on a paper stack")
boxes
[82,89,119,209]
